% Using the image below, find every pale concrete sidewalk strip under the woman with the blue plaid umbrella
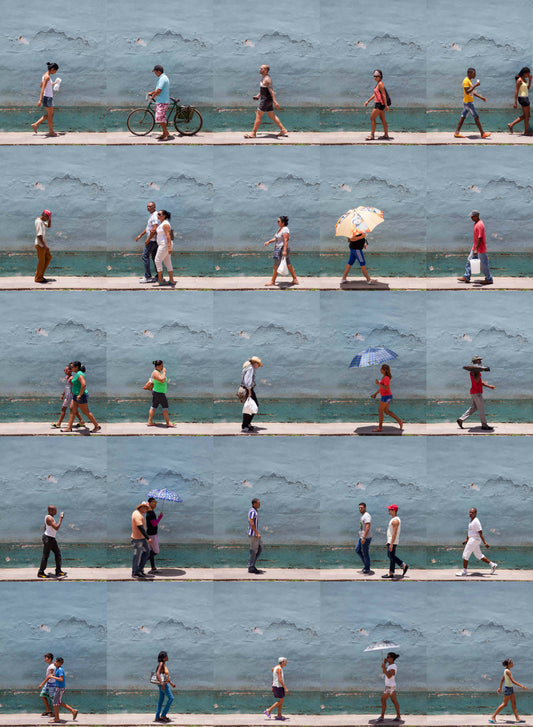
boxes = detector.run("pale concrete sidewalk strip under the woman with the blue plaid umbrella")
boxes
[0,421,533,437]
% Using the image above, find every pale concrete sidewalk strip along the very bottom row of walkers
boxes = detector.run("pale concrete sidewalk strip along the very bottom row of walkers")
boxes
[0,712,533,727]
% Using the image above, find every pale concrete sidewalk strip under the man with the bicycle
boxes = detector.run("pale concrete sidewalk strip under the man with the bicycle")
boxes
[0,131,533,146]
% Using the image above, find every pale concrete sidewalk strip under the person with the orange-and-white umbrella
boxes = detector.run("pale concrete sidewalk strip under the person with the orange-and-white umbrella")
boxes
[0,278,533,292]
